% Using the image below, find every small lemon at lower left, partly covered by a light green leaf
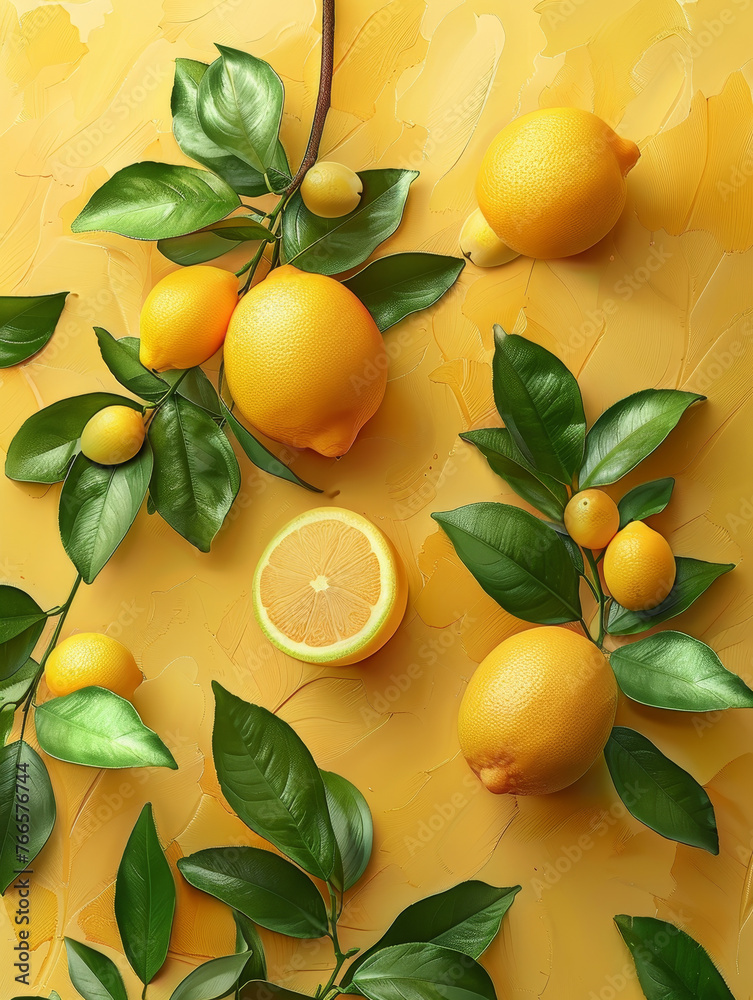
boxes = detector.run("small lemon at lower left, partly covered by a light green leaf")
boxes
[44,632,142,698]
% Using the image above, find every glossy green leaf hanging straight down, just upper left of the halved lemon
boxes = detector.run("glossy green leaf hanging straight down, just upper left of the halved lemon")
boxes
[149,395,241,552]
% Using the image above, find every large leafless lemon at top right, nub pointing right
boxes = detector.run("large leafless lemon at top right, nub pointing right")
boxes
[476,108,640,258]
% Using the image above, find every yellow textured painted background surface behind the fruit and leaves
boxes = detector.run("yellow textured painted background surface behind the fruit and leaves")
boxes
[0,0,753,1000]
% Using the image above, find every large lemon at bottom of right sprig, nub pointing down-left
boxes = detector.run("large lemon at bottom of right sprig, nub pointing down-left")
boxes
[458,626,617,795]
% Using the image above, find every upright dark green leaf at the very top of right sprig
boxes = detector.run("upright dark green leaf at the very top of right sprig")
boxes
[492,324,586,486]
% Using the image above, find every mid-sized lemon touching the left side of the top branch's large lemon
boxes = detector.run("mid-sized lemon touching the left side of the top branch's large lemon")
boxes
[139,264,238,371]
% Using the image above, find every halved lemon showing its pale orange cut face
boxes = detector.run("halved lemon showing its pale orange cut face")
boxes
[253,507,408,666]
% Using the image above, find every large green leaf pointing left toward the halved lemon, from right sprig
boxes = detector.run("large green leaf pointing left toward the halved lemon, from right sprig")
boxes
[431,503,581,625]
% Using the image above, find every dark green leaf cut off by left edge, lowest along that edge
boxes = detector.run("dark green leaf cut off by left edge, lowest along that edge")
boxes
[0,740,55,893]
